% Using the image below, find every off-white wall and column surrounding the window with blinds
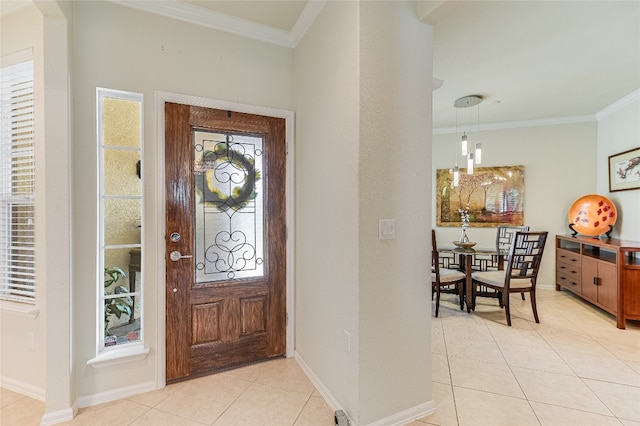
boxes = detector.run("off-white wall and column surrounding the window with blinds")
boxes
[0,2,74,414]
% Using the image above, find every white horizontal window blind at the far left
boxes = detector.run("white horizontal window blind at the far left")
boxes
[0,58,35,303]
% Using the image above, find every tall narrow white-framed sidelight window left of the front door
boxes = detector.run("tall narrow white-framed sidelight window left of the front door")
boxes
[96,88,144,353]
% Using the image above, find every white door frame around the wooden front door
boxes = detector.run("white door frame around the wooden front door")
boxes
[154,91,295,389]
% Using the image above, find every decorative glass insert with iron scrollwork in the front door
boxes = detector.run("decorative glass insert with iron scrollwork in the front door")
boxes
[194,130,265,285]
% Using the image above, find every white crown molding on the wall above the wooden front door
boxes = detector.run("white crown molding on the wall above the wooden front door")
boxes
[108,0,298,47]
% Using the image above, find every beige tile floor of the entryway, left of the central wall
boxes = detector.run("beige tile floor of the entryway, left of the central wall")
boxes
[0,359,334,426]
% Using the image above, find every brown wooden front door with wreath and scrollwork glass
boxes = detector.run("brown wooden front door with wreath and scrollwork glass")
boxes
[165,103,286,383]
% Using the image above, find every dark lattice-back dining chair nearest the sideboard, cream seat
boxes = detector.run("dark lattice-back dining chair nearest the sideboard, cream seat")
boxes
[471,231,548,326]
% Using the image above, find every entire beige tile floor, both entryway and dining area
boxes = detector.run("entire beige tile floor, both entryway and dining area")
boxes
[0,289,640,426]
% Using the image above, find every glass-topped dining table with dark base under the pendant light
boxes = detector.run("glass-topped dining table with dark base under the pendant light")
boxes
[438,246,505,313]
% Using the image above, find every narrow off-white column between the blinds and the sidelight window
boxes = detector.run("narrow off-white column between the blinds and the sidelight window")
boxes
[36,2,76,420]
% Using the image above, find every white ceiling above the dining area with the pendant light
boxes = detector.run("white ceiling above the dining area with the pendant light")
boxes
[424,1,640,128]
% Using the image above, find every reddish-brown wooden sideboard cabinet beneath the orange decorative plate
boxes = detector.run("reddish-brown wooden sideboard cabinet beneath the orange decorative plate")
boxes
[556,235,640,328]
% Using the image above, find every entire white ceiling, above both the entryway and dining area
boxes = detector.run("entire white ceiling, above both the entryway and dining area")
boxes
[3,0,640,131]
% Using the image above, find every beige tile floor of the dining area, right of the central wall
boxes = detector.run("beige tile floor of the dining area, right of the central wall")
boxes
[411,289,640,426]
